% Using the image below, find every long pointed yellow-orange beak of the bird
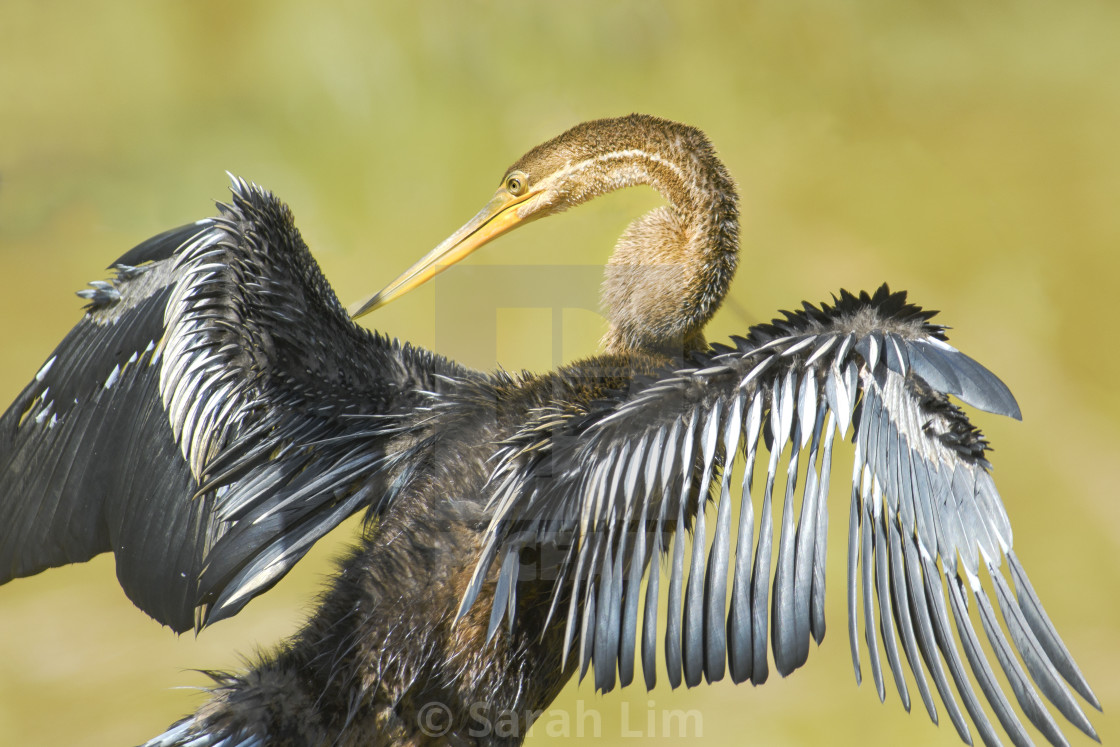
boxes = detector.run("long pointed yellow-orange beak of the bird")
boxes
[348,189,538,319]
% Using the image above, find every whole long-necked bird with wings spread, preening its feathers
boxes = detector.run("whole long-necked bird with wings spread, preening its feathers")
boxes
[0,114,1100,747]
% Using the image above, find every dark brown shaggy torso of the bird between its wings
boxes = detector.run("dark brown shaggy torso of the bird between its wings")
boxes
[173,356,676,745]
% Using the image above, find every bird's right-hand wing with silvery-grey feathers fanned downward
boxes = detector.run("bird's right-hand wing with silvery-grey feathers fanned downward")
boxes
[463,286,1099,745]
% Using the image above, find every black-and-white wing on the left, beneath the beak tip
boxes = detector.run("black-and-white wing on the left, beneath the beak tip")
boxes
[0,179,461,632]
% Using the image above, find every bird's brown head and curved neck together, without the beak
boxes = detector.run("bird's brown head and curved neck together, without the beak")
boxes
[506,114,739,355]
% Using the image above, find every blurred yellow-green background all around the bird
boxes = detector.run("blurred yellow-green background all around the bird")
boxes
[0,0,1120,746]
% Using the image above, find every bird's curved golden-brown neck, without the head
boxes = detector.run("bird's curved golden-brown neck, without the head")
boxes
[601,145,739,357]
